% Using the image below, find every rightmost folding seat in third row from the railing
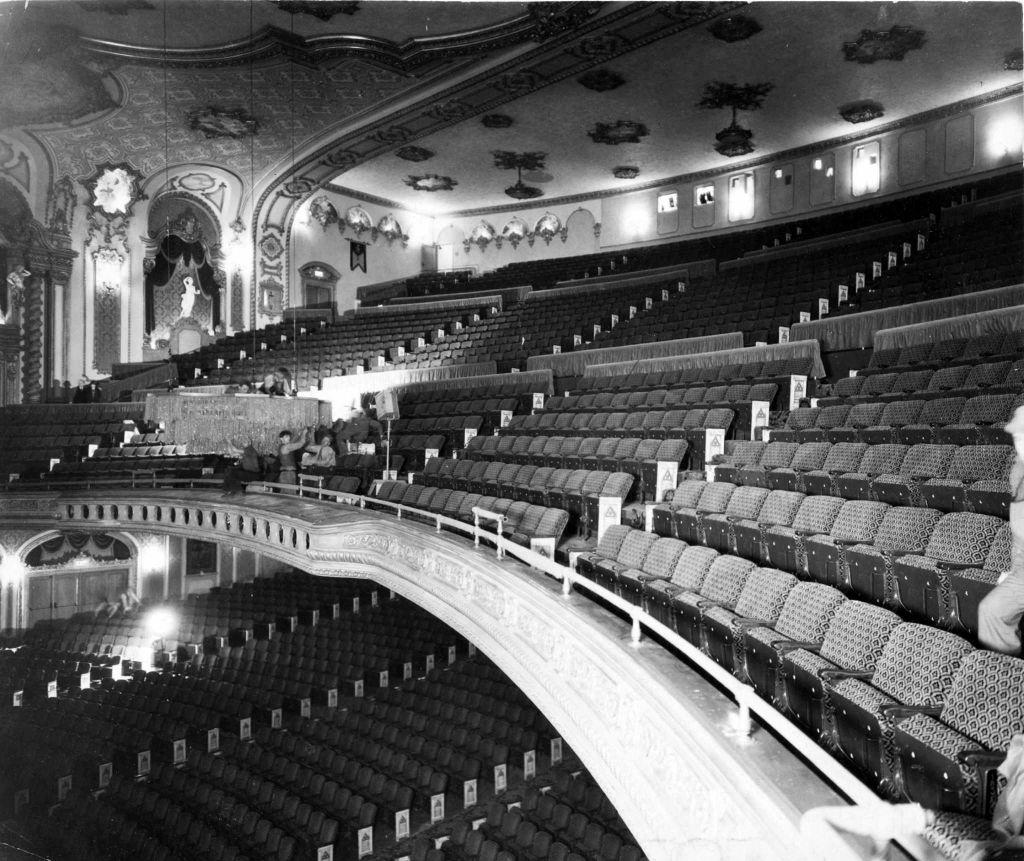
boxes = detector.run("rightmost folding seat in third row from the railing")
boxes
[921,445,1014,509]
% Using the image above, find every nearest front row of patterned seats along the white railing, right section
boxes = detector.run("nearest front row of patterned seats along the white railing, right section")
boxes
[580,526,1024,815]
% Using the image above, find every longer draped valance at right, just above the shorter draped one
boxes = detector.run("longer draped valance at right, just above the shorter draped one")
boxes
[790,284,1024,352]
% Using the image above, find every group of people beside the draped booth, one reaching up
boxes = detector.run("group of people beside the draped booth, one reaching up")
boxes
[224,411,383,497]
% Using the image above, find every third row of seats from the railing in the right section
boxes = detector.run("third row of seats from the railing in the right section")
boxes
[715,434,1013,517]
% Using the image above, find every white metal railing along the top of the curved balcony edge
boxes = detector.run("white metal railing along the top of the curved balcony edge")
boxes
[0,476,937,861]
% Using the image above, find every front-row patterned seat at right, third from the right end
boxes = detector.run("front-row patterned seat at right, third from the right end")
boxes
[779,601,902,738]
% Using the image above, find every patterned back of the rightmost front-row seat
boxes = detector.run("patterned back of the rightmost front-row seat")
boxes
[941,649,1024,750]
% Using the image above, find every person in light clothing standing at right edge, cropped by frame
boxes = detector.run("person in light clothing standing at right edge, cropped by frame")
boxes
[978,406,1024,655]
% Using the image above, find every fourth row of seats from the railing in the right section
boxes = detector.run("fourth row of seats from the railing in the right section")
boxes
[771,393,1024,444]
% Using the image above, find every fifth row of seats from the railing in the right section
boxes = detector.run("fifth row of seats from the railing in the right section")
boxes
[818,359,1024,406]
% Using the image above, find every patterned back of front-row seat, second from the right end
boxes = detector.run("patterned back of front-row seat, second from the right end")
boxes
[871,622,974,707]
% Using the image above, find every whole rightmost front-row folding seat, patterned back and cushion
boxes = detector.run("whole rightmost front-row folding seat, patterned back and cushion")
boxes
[890,650,1024,816]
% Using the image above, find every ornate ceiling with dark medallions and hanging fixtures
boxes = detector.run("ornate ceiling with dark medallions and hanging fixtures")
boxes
[0,0,1022,212]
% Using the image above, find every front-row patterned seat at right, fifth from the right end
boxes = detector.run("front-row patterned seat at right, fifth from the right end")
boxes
[701,568,797,673]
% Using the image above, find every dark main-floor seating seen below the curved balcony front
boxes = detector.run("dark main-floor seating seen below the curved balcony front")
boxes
[0,572,643,861]
